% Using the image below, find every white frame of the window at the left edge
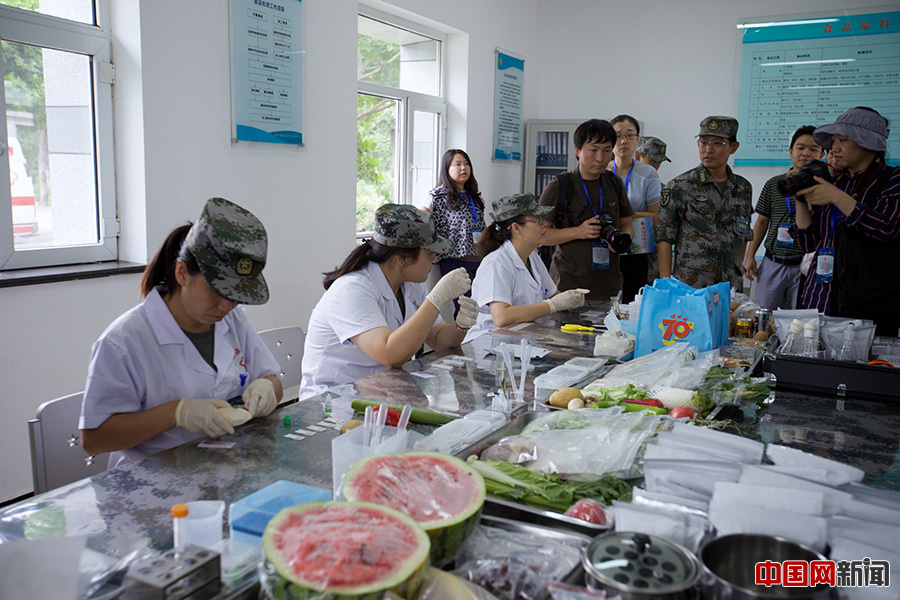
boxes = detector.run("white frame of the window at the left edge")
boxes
[0,0,119,270]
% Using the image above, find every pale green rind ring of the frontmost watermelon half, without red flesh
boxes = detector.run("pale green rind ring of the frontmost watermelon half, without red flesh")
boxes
[260,501,431,600]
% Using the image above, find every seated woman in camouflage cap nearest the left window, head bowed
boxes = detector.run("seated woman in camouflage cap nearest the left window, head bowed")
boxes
[79,198,282,467]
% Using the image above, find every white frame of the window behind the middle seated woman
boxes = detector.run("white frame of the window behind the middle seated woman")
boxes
[356,5,447,237]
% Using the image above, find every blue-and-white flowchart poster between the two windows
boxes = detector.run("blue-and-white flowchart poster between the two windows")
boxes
[231,0,303,146]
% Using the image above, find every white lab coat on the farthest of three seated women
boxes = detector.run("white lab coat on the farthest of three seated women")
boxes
[464,240,556,342]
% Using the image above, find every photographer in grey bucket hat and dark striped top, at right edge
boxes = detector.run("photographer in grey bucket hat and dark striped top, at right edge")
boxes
[792,106,900,336]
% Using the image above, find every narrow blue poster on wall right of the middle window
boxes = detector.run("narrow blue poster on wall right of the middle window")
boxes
[491,48,525,161]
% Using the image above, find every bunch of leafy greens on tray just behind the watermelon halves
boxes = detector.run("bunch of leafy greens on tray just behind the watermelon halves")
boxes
[466,455,631,512]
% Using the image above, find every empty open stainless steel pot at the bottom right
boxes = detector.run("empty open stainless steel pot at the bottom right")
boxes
[699,533,832,600]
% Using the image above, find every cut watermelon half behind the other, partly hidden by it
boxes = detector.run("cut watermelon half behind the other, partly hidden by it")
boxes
[341,452,484,566]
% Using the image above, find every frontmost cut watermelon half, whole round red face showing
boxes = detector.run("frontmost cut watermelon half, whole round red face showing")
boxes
[260,502,431,600]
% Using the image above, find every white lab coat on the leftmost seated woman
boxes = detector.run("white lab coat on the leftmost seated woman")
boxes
[78,288,281,468]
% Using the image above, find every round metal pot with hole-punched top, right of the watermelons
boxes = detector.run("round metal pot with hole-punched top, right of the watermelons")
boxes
[581,531,700,600]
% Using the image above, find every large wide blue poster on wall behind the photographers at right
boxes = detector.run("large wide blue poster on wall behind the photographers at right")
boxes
[734,12,900,166]
